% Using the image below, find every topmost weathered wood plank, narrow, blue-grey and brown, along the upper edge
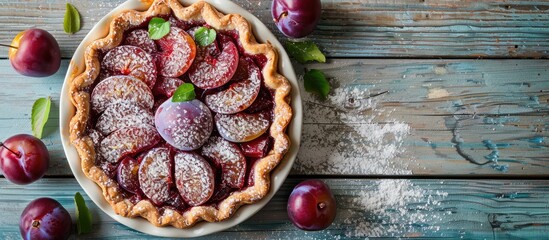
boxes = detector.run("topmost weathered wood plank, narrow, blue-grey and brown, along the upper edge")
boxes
[0,0,549,58]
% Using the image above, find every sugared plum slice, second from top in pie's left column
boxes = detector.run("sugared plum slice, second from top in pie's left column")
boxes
[91,76,154,113]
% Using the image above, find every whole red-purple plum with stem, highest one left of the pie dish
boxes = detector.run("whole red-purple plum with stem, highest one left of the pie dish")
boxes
[8,28,61,77]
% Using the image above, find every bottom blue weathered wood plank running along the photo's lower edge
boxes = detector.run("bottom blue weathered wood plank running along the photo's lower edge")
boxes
[0,179,549,239]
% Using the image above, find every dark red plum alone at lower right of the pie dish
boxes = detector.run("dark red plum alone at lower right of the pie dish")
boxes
[287,179,337,231]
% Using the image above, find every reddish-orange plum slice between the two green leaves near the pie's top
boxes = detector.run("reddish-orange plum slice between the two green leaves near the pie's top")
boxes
[156,27,196,77]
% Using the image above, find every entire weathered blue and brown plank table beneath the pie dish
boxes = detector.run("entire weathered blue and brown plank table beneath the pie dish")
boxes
[0,0,549,239]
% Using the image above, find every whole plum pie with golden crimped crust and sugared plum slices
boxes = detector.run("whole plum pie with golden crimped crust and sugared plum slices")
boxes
[70,0,292,228]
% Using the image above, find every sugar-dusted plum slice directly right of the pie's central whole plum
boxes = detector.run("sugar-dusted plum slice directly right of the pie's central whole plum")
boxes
[215,113,270,143]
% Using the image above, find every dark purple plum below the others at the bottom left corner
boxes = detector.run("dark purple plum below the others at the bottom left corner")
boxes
[19,197,72,240]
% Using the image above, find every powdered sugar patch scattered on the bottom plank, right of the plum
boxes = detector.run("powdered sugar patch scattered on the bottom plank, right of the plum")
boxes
[341,179,451,237]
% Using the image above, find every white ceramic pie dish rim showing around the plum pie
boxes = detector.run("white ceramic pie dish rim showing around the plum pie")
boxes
[59,0,303,237]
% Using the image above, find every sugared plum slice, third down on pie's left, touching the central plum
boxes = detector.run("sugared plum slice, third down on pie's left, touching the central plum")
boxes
[95,102,154,135]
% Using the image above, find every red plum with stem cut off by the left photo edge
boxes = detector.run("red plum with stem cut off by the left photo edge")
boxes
[0,134,50,185]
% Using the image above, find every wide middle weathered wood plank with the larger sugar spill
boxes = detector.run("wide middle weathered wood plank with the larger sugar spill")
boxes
[0,60,549,176]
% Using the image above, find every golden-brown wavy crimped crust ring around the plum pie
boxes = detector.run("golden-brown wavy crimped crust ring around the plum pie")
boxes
[70,0,292,228]
